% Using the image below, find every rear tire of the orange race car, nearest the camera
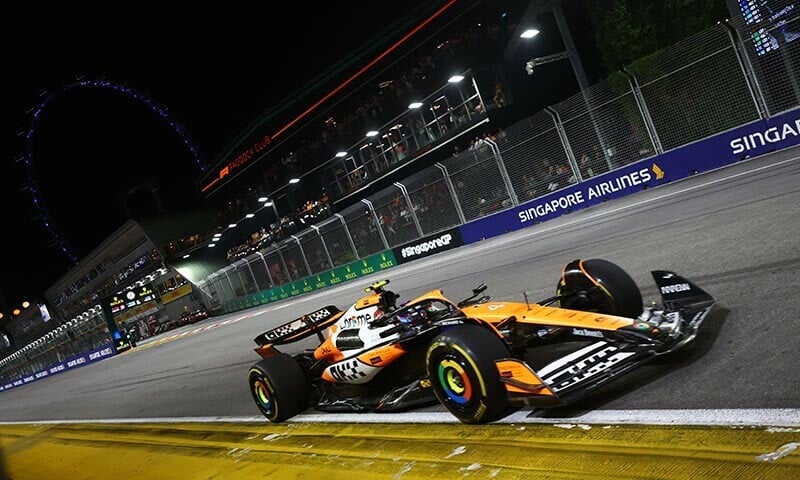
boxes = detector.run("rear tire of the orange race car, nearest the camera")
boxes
[248,353,311,423]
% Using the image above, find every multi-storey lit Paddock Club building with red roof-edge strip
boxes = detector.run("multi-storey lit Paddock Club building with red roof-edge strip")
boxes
[181,1,526,260]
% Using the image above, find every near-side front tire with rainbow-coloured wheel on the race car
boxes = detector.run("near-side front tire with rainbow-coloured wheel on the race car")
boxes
[425,325,511,423]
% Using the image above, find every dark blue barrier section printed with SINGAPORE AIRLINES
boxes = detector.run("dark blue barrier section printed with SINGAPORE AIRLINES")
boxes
[459,105,800,244]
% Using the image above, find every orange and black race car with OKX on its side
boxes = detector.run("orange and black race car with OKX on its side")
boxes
[249,259,714,423]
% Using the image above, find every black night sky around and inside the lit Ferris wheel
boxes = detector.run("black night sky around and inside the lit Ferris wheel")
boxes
[0,0,588,308]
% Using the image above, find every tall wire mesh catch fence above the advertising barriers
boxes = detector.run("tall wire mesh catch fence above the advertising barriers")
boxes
[200,20,800,312]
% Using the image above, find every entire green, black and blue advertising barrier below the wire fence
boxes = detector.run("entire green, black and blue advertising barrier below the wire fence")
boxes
[211,104,800,313]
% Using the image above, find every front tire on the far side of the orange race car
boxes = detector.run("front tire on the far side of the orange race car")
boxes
[556,259,643,318]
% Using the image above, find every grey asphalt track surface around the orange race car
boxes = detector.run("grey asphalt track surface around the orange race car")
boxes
[0,150,800,421]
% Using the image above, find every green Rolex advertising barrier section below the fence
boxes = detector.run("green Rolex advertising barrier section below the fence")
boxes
[223,250,397,313]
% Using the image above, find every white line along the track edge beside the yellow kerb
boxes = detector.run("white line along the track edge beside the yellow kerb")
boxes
[6,408,800,427]
